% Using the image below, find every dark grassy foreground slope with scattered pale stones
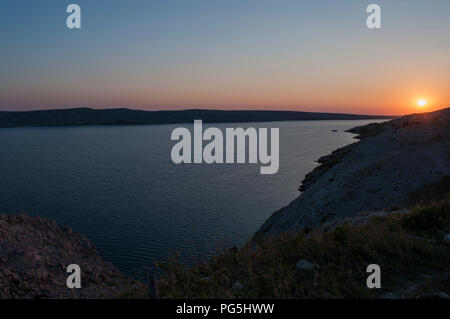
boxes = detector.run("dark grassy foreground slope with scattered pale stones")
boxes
[159,193,450,298]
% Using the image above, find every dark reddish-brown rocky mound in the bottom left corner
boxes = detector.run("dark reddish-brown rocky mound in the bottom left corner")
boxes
[0,214,146,299]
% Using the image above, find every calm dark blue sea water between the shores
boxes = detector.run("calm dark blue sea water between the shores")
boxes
[0,120,379,277]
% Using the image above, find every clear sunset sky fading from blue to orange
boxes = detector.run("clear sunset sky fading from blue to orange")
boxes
[0,0,450,115]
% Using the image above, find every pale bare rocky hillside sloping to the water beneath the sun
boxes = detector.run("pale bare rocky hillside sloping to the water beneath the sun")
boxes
[257,108,450,236]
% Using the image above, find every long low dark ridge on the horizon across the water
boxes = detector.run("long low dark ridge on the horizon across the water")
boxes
[0,108,394,128]
